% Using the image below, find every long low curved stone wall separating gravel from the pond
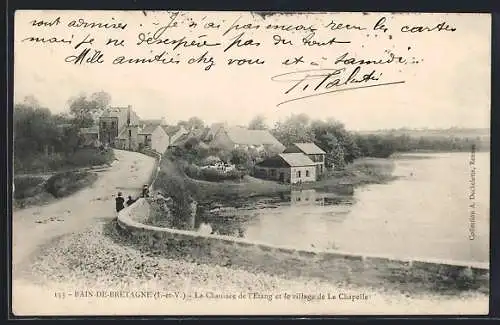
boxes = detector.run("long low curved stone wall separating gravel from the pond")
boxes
[118,199,489,294]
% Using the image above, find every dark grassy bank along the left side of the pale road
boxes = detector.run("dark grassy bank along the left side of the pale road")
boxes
[13,149,115,208]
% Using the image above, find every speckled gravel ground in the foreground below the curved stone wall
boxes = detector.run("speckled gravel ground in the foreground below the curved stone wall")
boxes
[13,221,488,314]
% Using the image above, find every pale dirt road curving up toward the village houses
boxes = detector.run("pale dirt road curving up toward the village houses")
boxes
[12,150,155,268]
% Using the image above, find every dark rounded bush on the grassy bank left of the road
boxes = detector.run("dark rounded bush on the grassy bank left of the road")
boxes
[45,172,97,198]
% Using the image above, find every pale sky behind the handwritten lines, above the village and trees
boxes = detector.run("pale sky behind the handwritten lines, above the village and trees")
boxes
[14,11,491,130]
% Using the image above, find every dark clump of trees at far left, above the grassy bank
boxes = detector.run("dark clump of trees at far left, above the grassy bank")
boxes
[13,93,113,173]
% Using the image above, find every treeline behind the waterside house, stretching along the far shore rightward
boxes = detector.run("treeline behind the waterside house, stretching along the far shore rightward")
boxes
[249,114,490,168]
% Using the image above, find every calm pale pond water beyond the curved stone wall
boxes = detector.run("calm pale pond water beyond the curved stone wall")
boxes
[196,153,490,262]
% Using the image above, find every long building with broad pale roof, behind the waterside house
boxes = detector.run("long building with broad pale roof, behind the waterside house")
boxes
[209,127,285,153]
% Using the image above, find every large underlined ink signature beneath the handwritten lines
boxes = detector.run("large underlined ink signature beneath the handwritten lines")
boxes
[271,66,405,106]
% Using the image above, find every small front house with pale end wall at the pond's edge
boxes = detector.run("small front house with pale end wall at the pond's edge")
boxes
[254,153,316,184]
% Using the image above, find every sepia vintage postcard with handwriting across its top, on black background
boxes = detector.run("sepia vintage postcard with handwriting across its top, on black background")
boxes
[12,10,491,316]
